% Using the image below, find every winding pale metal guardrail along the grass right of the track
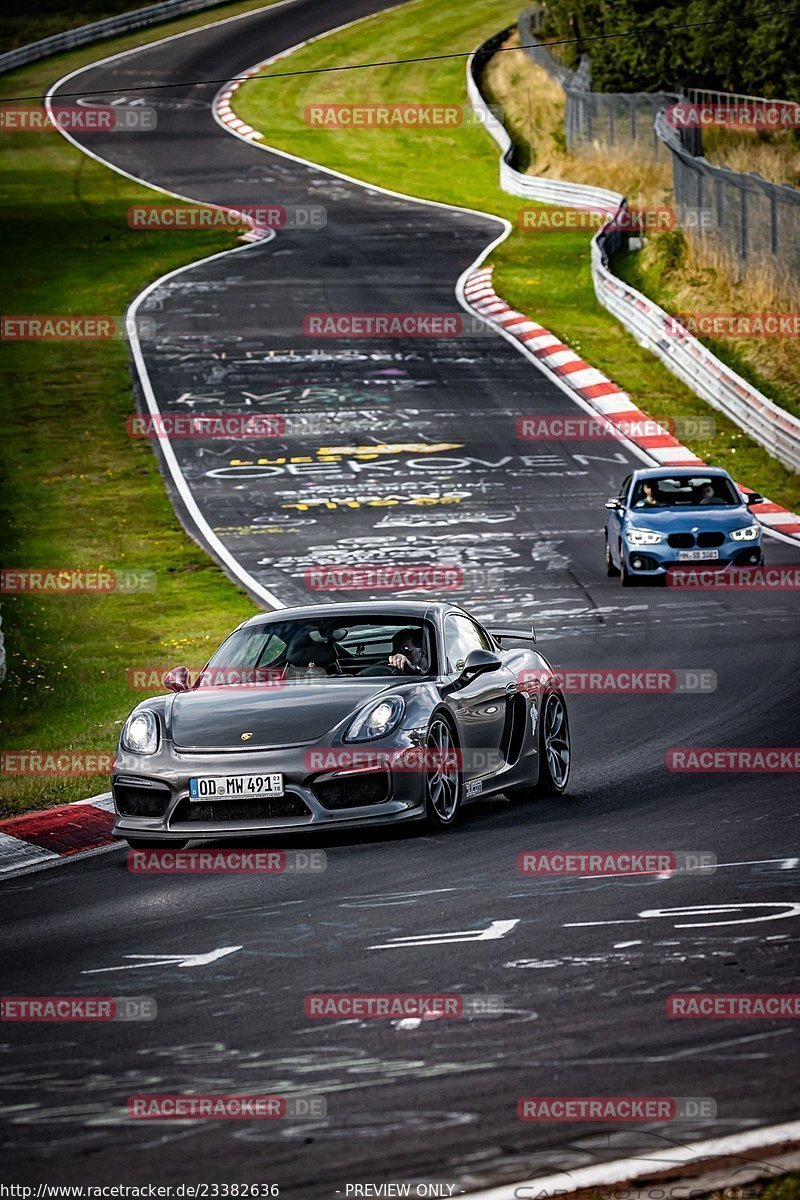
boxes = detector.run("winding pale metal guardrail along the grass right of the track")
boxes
[467,31,800,472]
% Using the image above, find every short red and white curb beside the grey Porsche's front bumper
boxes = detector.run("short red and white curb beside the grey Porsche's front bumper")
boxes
[0,792,116,878]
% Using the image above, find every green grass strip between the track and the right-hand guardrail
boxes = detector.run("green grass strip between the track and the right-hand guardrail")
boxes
[235,0,800,508]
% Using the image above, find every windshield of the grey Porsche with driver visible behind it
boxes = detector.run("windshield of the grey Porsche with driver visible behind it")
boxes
[198,616,435,686]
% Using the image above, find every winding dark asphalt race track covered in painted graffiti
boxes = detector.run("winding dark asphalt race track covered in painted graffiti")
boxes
[0,0,800,1198]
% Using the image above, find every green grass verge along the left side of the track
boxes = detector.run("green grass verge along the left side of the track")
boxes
[0,4,287,816]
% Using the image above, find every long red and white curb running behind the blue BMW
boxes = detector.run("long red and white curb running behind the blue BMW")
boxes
[464,266,800,542]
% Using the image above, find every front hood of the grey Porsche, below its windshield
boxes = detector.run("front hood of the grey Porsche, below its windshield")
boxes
[168,677,398,750]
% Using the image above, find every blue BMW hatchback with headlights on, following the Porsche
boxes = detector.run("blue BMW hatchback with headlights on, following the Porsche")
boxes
[606,467,764,587]
